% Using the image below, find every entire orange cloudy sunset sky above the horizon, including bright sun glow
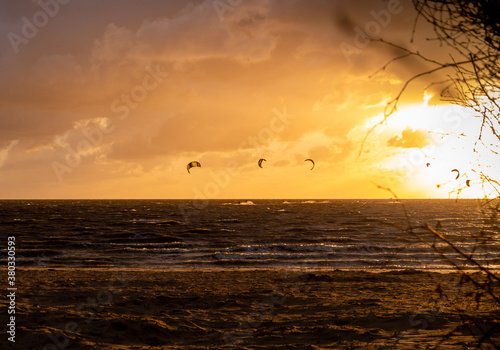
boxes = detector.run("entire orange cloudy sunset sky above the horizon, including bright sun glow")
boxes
[0,0,500,199]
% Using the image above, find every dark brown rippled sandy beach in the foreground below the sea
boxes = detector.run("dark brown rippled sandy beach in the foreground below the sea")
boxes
[1,269,500,350]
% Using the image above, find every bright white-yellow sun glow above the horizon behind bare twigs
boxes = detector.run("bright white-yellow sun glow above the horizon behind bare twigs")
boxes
[368,95,500,198]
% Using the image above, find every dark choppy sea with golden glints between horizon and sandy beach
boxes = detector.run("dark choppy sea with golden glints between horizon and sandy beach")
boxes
[0,199,500,270]
